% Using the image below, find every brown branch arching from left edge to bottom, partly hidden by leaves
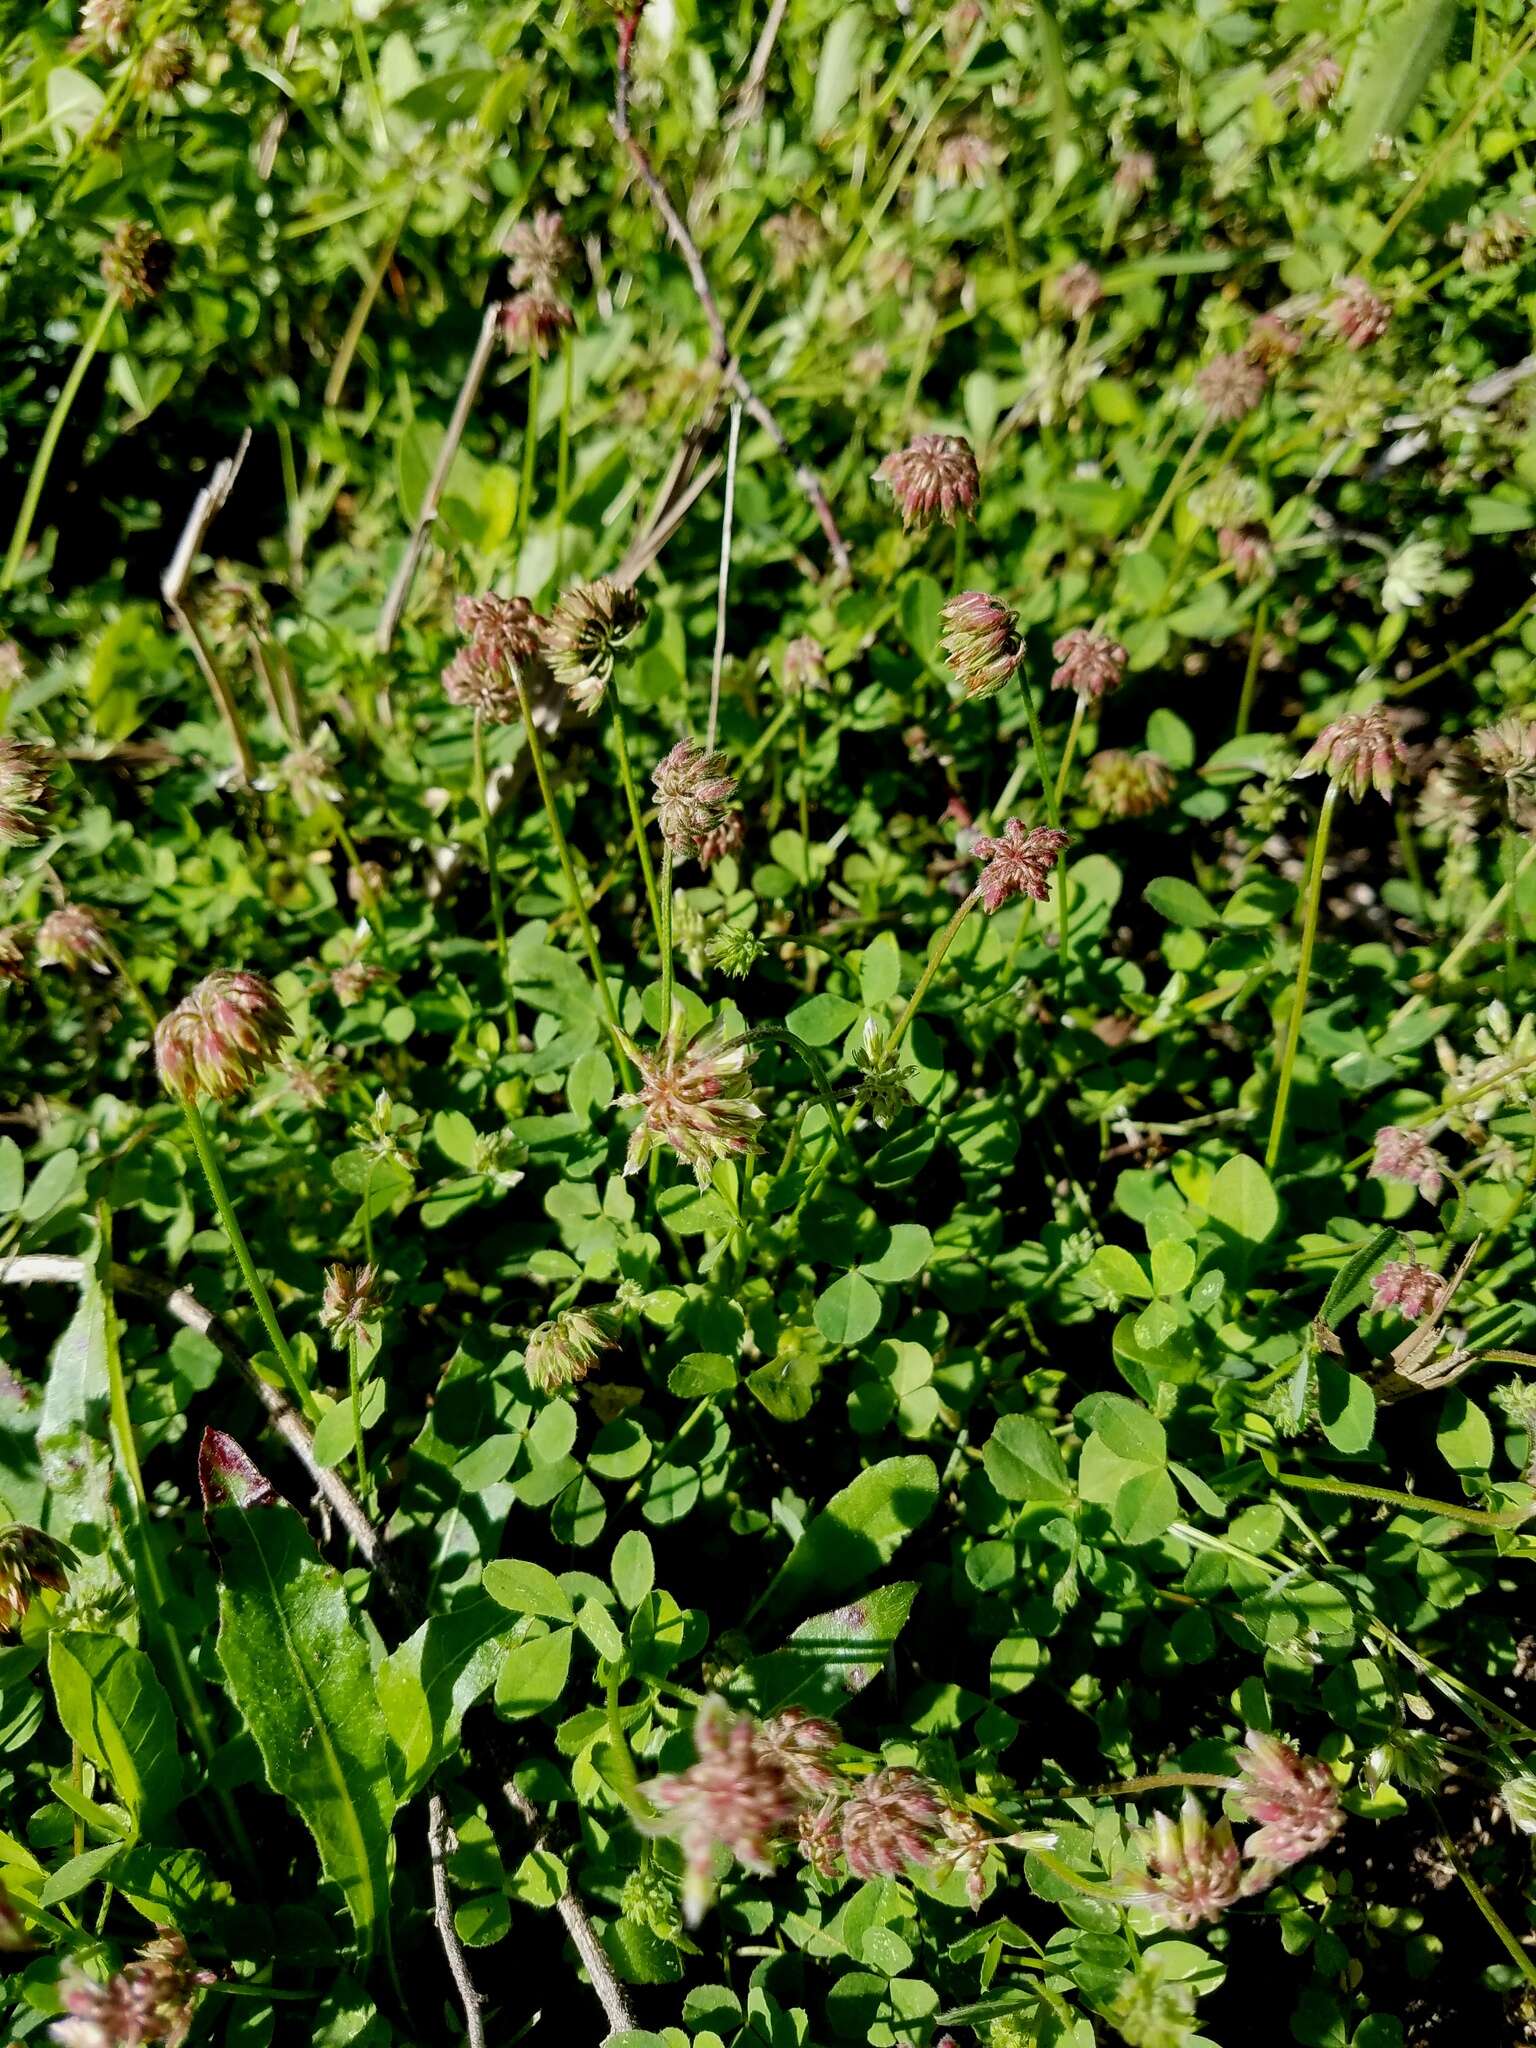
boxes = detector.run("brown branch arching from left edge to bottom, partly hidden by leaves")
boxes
[0,1251,635,2042]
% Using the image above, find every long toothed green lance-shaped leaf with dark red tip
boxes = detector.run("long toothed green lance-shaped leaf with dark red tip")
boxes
[209,1433,395,1952]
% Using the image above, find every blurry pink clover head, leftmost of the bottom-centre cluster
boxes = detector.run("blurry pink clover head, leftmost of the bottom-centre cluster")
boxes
[645,1698,801,1927]
